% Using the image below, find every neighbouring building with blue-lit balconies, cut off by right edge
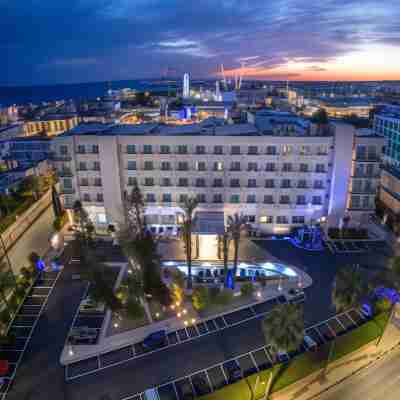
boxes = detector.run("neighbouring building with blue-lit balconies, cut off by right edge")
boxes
[374,106,400,215]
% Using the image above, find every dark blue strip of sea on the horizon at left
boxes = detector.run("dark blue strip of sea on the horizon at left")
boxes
[0,79,180,108]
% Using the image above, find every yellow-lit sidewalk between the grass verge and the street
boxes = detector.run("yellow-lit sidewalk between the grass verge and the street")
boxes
[271,323,400,400]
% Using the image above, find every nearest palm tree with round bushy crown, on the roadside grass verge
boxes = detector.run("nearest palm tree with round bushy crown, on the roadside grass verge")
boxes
[261,303,304,398]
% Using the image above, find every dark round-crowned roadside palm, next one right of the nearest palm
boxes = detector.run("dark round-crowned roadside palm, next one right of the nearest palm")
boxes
[324,266,368,373]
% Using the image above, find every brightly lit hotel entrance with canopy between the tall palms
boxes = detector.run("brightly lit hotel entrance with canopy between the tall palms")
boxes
[193,211,225,260]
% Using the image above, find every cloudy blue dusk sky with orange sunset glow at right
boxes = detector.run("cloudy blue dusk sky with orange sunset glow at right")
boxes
[0,0,400,85]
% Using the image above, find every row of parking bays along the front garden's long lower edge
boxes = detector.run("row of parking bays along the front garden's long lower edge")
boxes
[65,295,286,381]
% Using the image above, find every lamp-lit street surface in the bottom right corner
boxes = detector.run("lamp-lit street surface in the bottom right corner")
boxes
[319,349,400,400]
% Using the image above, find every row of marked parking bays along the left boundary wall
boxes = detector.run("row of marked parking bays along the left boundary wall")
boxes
[0,271,61,399]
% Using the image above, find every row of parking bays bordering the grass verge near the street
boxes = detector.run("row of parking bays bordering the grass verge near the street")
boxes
[121,309,366,400]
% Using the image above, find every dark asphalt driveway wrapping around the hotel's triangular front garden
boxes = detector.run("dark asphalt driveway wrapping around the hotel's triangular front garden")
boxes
[8,241,392,400]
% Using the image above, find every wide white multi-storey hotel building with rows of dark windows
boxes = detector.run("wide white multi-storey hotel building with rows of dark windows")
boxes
[52,120,378,233]
